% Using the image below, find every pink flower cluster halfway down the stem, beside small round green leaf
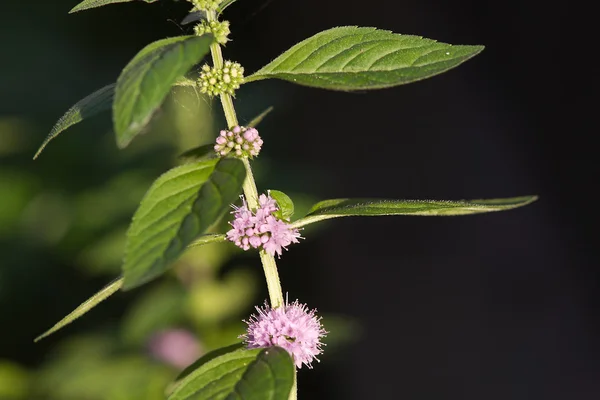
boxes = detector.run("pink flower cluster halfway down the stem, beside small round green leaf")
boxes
[227,194,300,256]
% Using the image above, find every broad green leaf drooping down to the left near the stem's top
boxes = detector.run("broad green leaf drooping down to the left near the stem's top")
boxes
[113,35,213,148]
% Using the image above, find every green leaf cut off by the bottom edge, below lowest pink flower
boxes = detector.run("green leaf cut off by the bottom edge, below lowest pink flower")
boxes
[168,345,295,400]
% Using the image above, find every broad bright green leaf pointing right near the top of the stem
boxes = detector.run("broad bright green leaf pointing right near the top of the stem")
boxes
[246,26,483,91]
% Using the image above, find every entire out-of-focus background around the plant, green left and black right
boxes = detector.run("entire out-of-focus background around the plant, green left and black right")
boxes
[0,0,600,400]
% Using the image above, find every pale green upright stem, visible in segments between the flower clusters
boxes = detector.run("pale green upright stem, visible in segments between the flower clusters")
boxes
[206,12,298,400]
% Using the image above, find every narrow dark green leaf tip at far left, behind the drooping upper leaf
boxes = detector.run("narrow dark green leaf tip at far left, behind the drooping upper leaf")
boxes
[33,83,115,160]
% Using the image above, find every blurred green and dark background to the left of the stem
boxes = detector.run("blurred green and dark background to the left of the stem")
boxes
[0,0,356,400]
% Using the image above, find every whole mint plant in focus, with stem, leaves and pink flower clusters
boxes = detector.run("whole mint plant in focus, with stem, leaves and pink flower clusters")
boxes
[34,0,536,400]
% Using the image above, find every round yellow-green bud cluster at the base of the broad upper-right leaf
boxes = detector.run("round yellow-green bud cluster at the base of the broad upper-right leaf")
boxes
[198,61,244,96]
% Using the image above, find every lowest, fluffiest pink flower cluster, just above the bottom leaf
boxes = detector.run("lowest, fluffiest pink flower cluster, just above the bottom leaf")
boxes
[240,300,327,368]
